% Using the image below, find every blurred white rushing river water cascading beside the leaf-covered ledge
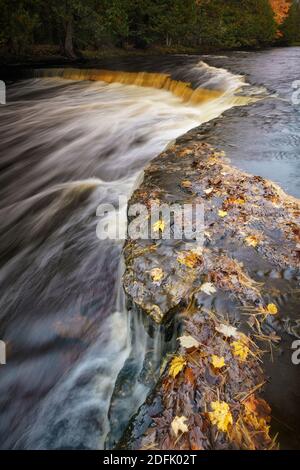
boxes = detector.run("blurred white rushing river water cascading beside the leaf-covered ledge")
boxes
[0,49,300,449]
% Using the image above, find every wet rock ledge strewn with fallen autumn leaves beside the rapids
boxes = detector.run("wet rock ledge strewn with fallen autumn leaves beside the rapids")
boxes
[119,126,300,450]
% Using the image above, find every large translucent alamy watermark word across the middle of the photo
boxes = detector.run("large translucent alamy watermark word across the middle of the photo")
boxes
[96,196,204,245]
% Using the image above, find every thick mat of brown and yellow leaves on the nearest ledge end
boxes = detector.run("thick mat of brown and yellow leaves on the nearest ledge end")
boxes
[124,311,276,450]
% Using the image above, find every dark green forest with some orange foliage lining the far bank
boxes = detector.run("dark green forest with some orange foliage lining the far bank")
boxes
[0,0,300,59]
